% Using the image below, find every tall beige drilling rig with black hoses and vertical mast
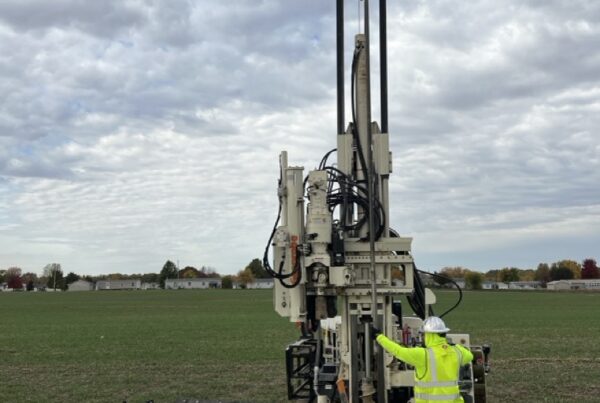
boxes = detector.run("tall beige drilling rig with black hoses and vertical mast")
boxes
[263,0,490,403]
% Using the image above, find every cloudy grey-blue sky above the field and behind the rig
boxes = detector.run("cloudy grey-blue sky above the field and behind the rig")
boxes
[0,0,600,274]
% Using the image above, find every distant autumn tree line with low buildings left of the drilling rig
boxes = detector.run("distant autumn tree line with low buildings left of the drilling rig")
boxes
[0,259,269,291]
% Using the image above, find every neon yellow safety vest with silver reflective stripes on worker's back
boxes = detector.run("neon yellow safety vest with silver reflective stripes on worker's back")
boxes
[415,344,463,403]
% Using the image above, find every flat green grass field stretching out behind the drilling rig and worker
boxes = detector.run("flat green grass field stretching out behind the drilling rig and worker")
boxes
[0,290,600,402]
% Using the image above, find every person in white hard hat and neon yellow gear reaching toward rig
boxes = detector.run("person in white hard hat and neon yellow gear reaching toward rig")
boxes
[372,316,473,403]
